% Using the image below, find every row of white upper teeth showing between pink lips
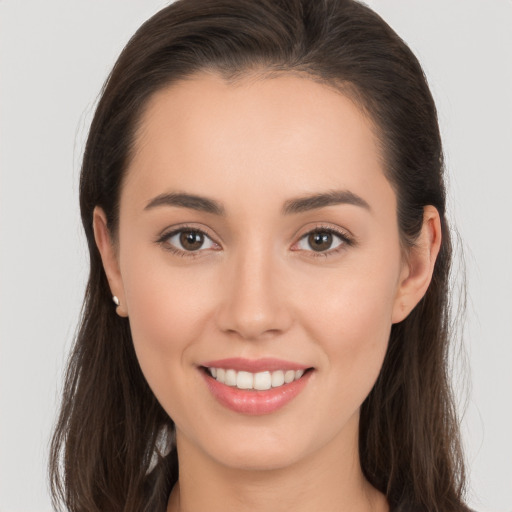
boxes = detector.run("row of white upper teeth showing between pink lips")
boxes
[208,368,304,391]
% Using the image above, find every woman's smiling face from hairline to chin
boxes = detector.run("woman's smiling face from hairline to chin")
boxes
[94,74,422,469]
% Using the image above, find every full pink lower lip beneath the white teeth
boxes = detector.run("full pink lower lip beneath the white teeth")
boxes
[201,370,313,415]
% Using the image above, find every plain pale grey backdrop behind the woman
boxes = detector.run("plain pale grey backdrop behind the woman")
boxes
[0,0,512,512]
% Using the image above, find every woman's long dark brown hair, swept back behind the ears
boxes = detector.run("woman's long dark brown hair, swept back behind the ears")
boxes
[49,0,467,512]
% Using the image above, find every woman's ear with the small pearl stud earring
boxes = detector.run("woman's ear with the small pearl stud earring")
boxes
[92,206,128,317]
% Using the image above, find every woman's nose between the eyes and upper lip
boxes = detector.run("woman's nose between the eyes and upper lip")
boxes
[217,243,292,340]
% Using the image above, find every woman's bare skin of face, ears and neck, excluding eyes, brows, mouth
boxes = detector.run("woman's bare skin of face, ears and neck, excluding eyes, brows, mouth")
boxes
[94,73,441,512]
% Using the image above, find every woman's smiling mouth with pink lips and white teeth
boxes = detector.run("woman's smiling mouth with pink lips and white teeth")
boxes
[199,359,314,415]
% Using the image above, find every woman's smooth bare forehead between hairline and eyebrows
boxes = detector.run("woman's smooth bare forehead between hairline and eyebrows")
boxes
[121,73,387,214]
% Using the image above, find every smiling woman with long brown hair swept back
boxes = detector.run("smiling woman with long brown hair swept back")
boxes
[50,0,467,512]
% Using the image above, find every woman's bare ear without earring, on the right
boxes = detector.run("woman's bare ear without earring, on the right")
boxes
[392,205,442,323]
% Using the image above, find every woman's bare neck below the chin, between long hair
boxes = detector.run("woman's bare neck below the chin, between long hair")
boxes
[167,414,389,512]
